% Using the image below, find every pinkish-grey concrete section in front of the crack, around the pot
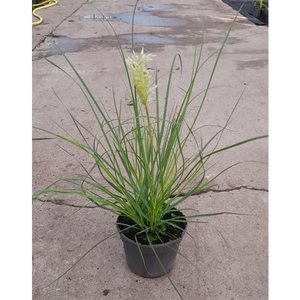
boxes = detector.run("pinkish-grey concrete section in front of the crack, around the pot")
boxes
[33,189,268,300]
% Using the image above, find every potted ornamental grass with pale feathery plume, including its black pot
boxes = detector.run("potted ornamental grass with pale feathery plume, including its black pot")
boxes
[33,2,267,298]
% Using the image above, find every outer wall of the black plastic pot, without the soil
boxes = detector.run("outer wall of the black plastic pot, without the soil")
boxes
[117,212,184,278]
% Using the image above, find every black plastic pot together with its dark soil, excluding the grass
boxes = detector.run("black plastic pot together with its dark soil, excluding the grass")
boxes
[117,210,187,278]
